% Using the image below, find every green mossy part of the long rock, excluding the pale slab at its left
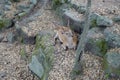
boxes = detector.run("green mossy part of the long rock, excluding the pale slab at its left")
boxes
[33,32,54,80]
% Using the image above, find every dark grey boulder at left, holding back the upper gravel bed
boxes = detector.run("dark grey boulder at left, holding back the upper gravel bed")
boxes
[15,22,36,44]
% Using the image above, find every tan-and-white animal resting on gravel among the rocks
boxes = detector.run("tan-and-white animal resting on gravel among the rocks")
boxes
[54,26,78,50]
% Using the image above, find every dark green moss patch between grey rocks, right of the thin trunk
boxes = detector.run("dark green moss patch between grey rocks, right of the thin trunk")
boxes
[96,39,108,56]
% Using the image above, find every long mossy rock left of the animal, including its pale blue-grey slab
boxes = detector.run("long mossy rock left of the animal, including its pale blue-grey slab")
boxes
[29,31,54,80]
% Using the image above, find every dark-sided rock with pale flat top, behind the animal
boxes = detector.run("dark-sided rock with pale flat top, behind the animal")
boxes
[62,10,84,33]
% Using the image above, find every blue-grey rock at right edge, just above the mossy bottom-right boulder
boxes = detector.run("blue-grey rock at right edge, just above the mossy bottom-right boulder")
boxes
[104,25,120,48]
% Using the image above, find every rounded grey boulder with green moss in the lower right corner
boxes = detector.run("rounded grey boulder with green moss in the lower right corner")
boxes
[103,48,120,77]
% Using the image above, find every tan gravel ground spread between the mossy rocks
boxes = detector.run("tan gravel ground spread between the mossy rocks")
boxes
[0,0,120,80]
